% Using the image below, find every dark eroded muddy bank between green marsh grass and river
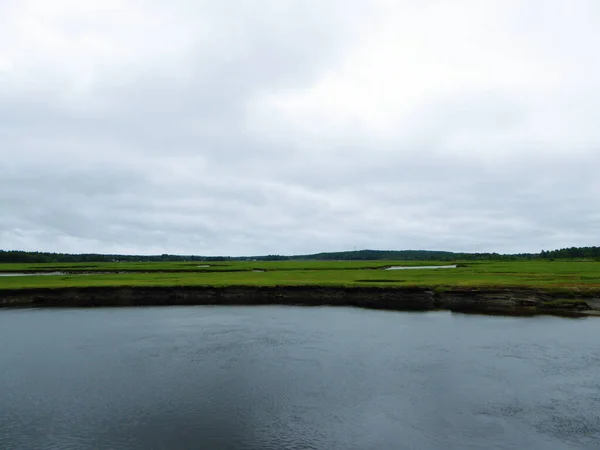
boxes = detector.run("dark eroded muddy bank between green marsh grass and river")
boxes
[0,286,600,315]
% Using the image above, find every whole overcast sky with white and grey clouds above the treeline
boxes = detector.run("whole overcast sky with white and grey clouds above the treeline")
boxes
[0,0,600,255]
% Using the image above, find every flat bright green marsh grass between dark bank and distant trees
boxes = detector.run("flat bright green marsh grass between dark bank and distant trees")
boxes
[0,260,600,294]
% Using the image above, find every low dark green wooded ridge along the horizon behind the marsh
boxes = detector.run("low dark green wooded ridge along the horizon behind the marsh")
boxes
[0,247,600,263]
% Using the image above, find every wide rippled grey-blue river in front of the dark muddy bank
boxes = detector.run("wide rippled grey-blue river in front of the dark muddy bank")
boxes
[0,307,600,450]
